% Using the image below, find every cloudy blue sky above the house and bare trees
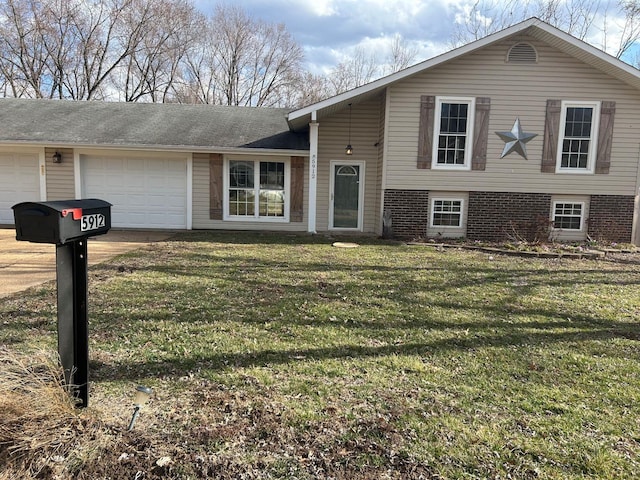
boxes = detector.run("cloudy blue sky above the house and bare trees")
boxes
[194,0,636,74]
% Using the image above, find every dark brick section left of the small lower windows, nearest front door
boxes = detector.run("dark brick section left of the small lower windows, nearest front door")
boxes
[384,190,429,239]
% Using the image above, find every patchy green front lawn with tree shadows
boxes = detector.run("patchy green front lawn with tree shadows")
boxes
[0,232,640,479]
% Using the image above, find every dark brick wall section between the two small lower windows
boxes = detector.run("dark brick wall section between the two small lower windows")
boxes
[467,192,551,242]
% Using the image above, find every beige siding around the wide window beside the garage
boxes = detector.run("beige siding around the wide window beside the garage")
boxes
[193,153,309,232]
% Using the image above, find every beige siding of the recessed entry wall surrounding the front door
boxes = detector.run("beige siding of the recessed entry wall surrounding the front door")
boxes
[317,97,383,233]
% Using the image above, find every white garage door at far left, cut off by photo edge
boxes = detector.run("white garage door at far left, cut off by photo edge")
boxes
[0,153,40,225]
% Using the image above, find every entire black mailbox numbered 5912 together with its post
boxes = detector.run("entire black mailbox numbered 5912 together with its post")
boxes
[13,199,111,407]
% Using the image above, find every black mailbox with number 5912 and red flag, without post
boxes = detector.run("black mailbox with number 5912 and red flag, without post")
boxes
[13,198,111,245]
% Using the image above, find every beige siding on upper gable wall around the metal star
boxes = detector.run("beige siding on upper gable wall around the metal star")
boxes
[386,36,640,195]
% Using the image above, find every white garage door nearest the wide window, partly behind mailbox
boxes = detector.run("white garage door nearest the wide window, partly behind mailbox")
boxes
[81,155,187,228]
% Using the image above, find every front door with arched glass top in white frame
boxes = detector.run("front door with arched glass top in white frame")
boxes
[330,162,364,230]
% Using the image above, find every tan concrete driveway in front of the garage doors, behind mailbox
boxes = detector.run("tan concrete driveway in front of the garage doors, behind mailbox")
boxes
[0,228,173,297]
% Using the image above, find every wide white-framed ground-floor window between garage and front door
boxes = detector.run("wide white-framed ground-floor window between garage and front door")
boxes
[226,160,289,220]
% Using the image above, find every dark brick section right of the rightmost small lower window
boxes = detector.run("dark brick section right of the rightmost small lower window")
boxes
[588,195,634,243]
